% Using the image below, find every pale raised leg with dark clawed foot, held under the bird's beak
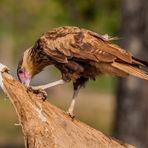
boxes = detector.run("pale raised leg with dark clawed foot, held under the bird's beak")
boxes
[28,79,65,100]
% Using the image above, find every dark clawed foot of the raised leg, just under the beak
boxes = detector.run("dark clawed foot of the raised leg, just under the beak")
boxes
[27,87,47,101]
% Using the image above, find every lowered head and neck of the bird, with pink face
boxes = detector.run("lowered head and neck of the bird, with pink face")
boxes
[17,44,51,86]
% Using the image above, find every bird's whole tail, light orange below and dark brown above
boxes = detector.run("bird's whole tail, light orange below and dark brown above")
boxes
[111,57,148,80]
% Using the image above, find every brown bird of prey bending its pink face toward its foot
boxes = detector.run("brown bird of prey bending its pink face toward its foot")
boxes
[17,26,148,117]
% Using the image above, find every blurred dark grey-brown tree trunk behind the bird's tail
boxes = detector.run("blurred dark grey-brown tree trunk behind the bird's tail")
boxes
[114,0,148,148]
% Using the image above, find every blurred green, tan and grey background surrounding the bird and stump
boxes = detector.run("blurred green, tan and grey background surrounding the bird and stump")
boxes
[0,0,148,148]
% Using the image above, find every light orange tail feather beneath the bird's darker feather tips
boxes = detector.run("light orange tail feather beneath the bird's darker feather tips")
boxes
[111,61,148,80]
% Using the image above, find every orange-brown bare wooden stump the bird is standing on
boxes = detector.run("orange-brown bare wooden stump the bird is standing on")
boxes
[0,64,133,148]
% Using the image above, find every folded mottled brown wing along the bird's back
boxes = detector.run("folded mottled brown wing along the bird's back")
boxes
[38,27,132,63]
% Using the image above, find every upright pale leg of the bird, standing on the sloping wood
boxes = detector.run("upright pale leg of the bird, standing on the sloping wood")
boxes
[67,88,79,118]
